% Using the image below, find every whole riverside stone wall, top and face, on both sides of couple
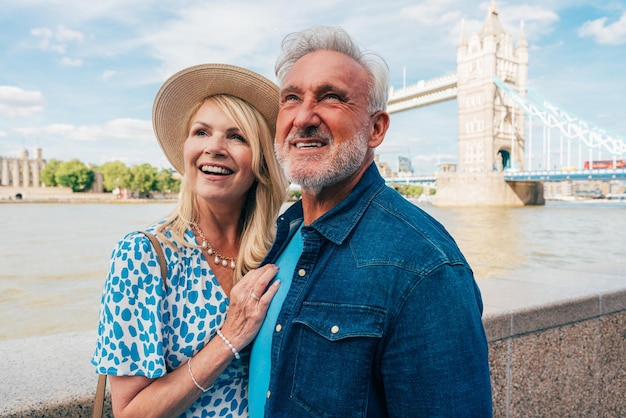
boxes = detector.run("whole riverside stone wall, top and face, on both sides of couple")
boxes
[0,260,626,417]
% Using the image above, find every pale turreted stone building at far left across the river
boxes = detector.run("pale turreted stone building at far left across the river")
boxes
[0,147,46,187]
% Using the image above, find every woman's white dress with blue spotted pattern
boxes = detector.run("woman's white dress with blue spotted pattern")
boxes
[91,224,250,417]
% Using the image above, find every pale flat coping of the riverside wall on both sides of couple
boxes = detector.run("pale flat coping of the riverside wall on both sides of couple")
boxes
[0,264,626,417]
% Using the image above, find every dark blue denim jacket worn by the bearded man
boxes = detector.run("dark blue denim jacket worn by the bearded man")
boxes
[260,164,492,418]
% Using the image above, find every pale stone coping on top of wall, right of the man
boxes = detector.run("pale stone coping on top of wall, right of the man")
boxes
[478,264,626,342]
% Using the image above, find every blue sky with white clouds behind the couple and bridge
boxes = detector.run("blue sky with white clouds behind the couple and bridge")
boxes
[0,0,626,174]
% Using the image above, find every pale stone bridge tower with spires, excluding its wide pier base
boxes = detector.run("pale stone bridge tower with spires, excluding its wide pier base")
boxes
[457,1,528,173]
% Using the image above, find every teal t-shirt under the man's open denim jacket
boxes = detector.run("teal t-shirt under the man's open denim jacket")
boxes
[248,225,303,418]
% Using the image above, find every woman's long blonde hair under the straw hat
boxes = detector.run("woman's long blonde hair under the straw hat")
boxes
[156,94,288,283]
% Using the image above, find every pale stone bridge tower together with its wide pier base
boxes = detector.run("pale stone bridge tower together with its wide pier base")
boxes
[433,0,545,206]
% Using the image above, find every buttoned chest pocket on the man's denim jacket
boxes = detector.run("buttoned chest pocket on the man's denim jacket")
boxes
[291,302,386,417]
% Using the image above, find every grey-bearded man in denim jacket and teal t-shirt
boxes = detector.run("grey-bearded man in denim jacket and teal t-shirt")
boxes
[249,27,492,418]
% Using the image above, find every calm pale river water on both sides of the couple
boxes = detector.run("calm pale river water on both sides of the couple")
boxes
[0,201,626,340]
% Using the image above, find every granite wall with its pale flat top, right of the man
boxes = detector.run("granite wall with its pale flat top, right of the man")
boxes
[479,264,626,417]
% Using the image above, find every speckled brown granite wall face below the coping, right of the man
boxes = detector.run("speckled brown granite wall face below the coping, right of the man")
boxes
[489,305,626,417]
